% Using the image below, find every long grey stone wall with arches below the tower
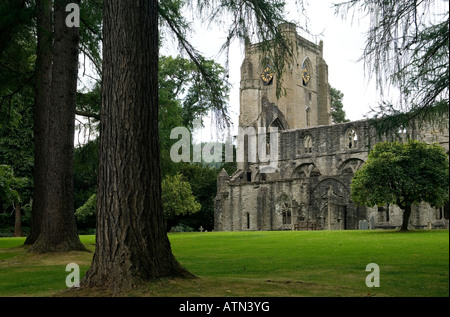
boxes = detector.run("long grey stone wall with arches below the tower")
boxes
[215,121,449,231]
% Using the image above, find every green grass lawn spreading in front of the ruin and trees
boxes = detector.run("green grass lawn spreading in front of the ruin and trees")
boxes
[0,230,449,297]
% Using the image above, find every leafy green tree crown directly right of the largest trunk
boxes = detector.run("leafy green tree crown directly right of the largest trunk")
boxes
[158,56,230,177]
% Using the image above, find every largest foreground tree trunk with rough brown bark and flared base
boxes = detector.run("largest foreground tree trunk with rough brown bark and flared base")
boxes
[82,0,192,292]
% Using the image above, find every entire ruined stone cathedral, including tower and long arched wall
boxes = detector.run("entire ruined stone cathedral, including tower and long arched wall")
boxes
[214,23,449,231]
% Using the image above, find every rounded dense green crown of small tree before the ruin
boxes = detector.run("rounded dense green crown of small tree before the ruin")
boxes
[351,140,449,209]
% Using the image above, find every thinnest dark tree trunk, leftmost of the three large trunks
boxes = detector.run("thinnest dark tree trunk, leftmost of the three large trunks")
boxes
[25,0,53,245]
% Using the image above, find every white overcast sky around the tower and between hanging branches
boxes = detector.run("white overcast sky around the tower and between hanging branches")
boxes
[161,0,386,141]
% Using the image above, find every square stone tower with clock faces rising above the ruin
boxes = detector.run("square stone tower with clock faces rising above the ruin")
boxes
[239,23,331,130]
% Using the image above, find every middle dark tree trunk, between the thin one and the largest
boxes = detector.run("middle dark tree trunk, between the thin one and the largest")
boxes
[31,0,85,253]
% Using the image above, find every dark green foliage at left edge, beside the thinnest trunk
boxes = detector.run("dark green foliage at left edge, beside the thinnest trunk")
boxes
[0,0,36,193]
